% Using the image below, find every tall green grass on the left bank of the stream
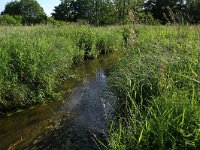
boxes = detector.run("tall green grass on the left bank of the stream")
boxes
[0,24,128,111]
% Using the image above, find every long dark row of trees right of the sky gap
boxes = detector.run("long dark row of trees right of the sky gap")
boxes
[52,0,200,25]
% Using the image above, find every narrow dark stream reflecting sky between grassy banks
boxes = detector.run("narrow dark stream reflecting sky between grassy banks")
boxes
[0,53,118,150]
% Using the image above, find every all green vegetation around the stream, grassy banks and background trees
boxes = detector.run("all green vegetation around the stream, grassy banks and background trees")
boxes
[0,0,200,150]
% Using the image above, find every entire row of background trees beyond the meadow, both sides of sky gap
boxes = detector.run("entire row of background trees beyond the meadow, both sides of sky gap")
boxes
[1,0,200,26]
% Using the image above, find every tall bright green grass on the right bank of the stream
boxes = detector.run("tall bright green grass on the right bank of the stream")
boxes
[107,25,200,149]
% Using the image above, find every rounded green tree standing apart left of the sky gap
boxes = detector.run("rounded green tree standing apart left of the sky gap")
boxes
[2,0,47,24]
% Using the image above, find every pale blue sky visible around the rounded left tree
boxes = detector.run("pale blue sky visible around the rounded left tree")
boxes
[0,0,60,16]
